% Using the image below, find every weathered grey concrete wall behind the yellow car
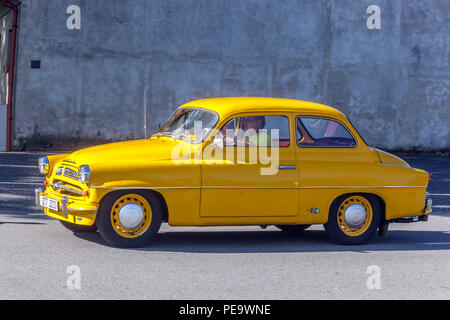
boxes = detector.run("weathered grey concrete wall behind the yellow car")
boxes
[9,0,450,150]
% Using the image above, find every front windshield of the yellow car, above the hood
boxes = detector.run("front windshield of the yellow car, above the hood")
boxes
[157,108,219,143]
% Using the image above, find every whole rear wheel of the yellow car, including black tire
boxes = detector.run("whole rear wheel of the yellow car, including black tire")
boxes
[324,194,381,245]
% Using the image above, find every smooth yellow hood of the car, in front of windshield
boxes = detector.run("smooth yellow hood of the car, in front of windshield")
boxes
[64,138,180,166]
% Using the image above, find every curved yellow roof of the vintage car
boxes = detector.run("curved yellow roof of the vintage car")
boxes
[180,97,345,118]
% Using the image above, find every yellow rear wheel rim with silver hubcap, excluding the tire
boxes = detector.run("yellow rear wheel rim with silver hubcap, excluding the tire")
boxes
[337,196,373,237]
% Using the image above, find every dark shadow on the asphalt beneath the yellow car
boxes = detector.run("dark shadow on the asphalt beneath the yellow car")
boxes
[74,230,450,253]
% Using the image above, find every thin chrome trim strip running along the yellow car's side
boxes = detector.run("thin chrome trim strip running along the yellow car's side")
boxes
[91,186,427,190]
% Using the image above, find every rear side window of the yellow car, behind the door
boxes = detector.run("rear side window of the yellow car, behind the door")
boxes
[296,117,356,147]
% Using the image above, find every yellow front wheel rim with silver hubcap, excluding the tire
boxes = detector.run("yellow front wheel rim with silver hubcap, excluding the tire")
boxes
[110,194,152,238]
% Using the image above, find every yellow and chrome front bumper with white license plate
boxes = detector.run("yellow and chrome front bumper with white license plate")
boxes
[35,188,98,226]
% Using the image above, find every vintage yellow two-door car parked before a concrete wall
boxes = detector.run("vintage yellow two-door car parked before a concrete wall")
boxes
[35,97,431,247]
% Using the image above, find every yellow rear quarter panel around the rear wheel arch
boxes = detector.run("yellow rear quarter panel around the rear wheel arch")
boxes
[299,148,428,224]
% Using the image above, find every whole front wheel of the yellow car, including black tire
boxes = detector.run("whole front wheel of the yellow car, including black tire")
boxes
[97,190,162,248]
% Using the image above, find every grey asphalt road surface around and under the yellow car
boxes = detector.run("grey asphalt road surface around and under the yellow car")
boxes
[0,153,450,300]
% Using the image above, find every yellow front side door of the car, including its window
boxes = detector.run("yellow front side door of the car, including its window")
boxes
[200,113,299,217]
